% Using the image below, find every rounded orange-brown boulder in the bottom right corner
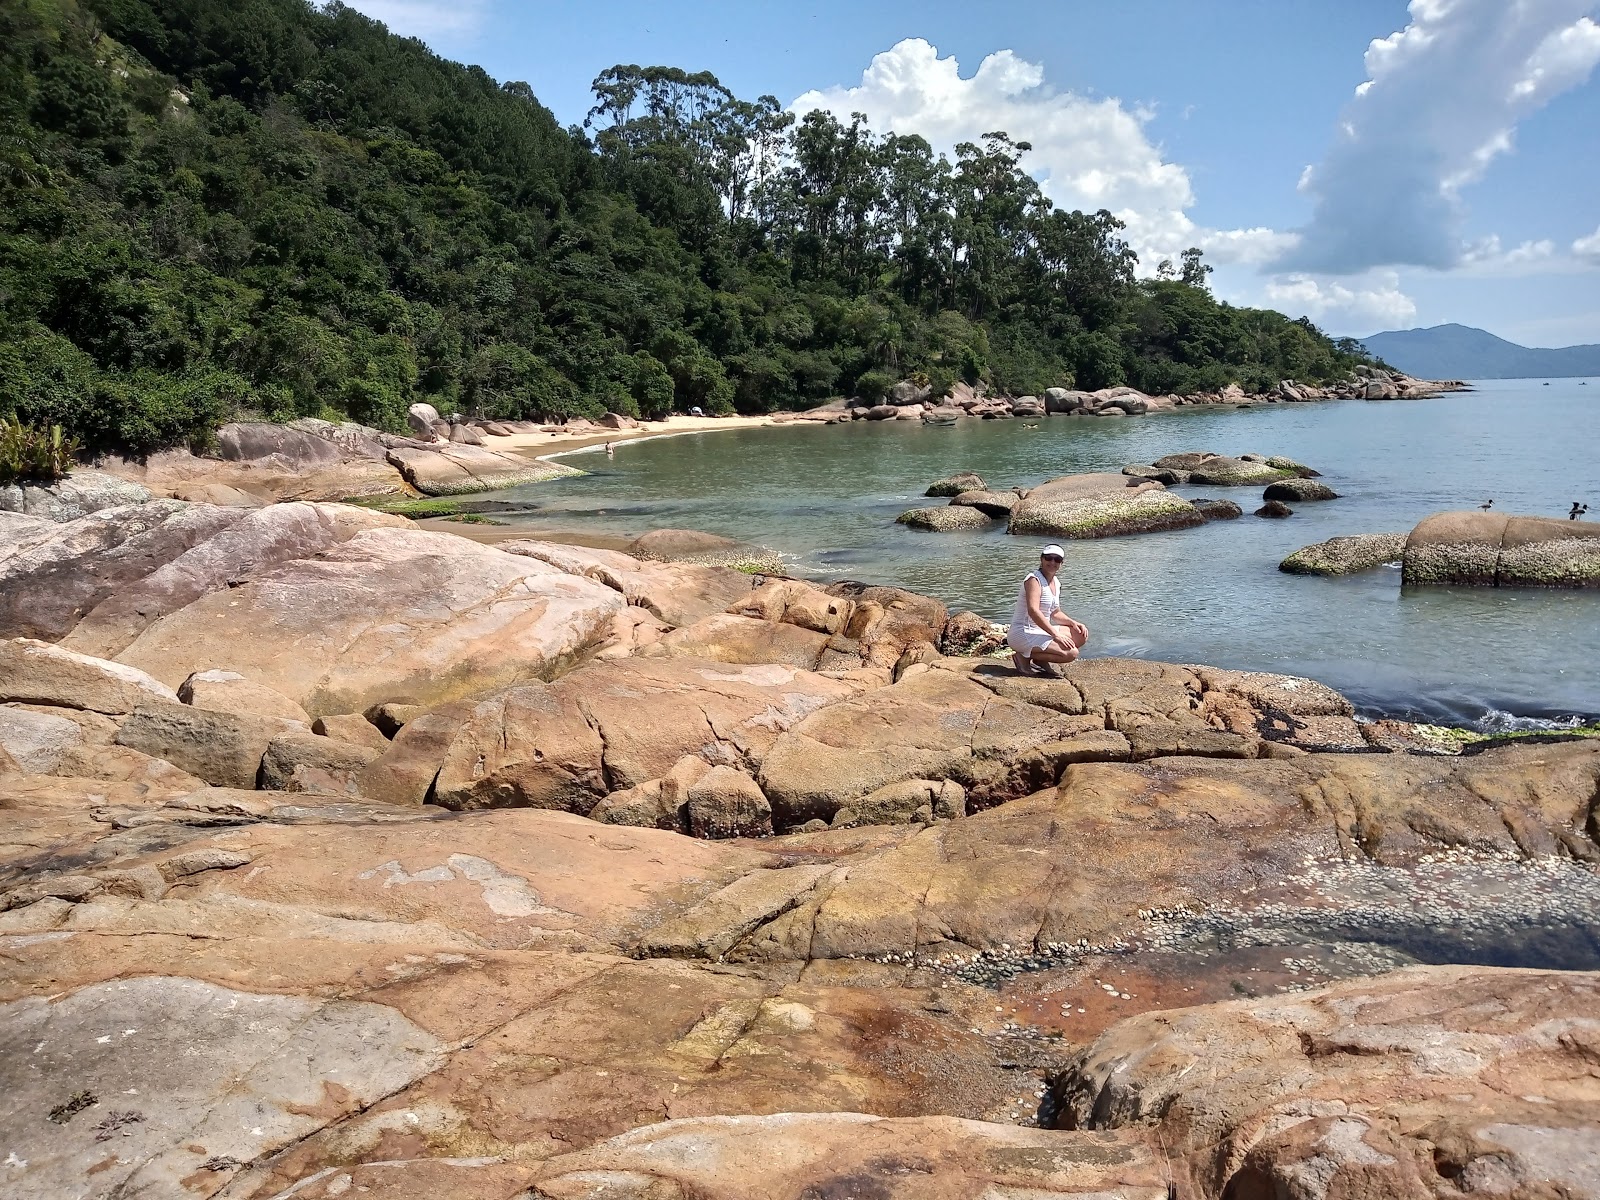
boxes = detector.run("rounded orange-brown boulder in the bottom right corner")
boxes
[1051,966,1600,1200]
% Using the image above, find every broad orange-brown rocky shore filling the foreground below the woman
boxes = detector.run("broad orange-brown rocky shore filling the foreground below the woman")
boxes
[0,489,1600,1200]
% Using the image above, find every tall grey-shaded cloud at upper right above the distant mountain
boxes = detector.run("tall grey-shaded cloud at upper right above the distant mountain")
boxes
[1280,0,1600,274]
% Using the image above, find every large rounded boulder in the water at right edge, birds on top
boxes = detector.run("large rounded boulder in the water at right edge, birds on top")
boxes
[1402,512,1600,587]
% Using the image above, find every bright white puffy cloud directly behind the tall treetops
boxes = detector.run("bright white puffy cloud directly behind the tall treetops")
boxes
[789,38,1209,269]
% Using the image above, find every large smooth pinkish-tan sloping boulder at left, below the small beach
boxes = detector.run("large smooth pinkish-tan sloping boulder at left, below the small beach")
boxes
[115,528,626,717]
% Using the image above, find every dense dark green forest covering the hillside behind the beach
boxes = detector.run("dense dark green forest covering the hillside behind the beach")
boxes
[0,0,1358,454]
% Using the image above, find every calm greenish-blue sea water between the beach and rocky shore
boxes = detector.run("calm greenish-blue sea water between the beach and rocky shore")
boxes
[496,379,1600,726]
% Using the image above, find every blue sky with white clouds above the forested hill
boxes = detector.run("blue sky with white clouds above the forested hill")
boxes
[337,0,1600,346]
